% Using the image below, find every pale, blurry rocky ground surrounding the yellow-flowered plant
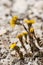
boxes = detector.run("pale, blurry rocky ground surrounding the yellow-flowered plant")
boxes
[0,0,43,65]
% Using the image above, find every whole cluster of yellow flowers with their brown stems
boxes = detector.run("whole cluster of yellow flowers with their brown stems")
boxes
[10,16,35,59]
